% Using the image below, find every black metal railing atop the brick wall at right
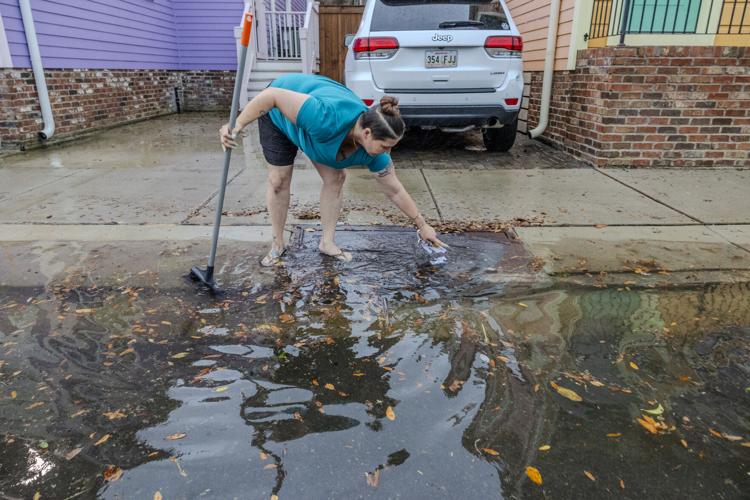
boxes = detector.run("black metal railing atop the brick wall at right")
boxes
[587,0,750,43]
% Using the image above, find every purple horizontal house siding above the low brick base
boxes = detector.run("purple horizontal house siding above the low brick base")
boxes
[0,0,244,69]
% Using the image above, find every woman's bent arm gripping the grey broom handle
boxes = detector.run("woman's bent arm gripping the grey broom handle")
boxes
[219,87,310,148]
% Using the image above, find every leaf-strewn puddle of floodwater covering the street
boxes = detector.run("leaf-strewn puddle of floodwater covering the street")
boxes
[0,232,750,499]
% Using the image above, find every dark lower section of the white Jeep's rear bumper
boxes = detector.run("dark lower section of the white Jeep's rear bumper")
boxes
[399,105,518,128]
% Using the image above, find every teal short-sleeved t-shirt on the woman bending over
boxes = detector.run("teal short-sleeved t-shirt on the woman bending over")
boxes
[269,74,391,172]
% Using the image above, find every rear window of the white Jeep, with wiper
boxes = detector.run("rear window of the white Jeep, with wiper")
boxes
[370,0,510,31]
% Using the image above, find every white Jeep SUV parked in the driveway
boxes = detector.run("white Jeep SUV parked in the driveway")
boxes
[344,0,523,151]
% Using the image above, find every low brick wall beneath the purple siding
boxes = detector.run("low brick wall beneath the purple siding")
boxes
[0,69,234,151]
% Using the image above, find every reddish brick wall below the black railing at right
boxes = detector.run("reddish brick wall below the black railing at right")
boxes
[526,47,750,167]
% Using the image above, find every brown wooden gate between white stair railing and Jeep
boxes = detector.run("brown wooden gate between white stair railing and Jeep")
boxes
[320,5,364,83]
